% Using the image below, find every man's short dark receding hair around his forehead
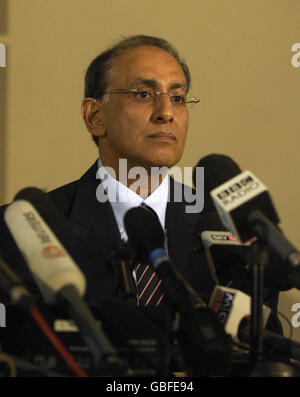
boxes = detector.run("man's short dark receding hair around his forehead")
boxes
[84,35,191,146]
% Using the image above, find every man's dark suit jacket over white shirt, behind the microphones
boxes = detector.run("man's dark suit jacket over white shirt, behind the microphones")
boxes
[0,162,278,332]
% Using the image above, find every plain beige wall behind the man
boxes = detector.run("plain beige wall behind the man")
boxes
[0,0,300,341]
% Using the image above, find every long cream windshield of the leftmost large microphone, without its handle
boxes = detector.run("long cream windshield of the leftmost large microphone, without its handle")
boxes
[4,196,86,303]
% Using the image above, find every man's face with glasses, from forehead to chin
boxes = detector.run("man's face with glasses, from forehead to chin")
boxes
[95,46,188,170]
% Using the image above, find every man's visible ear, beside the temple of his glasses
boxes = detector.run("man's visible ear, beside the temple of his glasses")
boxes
[81,98,105,137]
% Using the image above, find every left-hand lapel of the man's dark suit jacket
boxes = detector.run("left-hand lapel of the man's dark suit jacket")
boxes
[53,162,121,305]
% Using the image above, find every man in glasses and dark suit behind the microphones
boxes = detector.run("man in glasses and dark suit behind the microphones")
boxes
[0,36,277,324]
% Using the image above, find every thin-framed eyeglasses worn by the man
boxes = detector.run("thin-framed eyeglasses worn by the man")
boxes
[104,88,200,108]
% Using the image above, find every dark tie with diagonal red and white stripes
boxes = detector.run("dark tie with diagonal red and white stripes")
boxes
[135,203,164,306]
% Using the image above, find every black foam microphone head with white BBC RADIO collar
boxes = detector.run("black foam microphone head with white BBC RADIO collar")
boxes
[193,154,279,242]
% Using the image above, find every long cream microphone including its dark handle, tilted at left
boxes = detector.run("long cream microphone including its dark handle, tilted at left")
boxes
[4,188,125,371]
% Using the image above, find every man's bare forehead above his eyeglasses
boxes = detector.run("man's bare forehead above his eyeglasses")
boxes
[109,46,186,88]
